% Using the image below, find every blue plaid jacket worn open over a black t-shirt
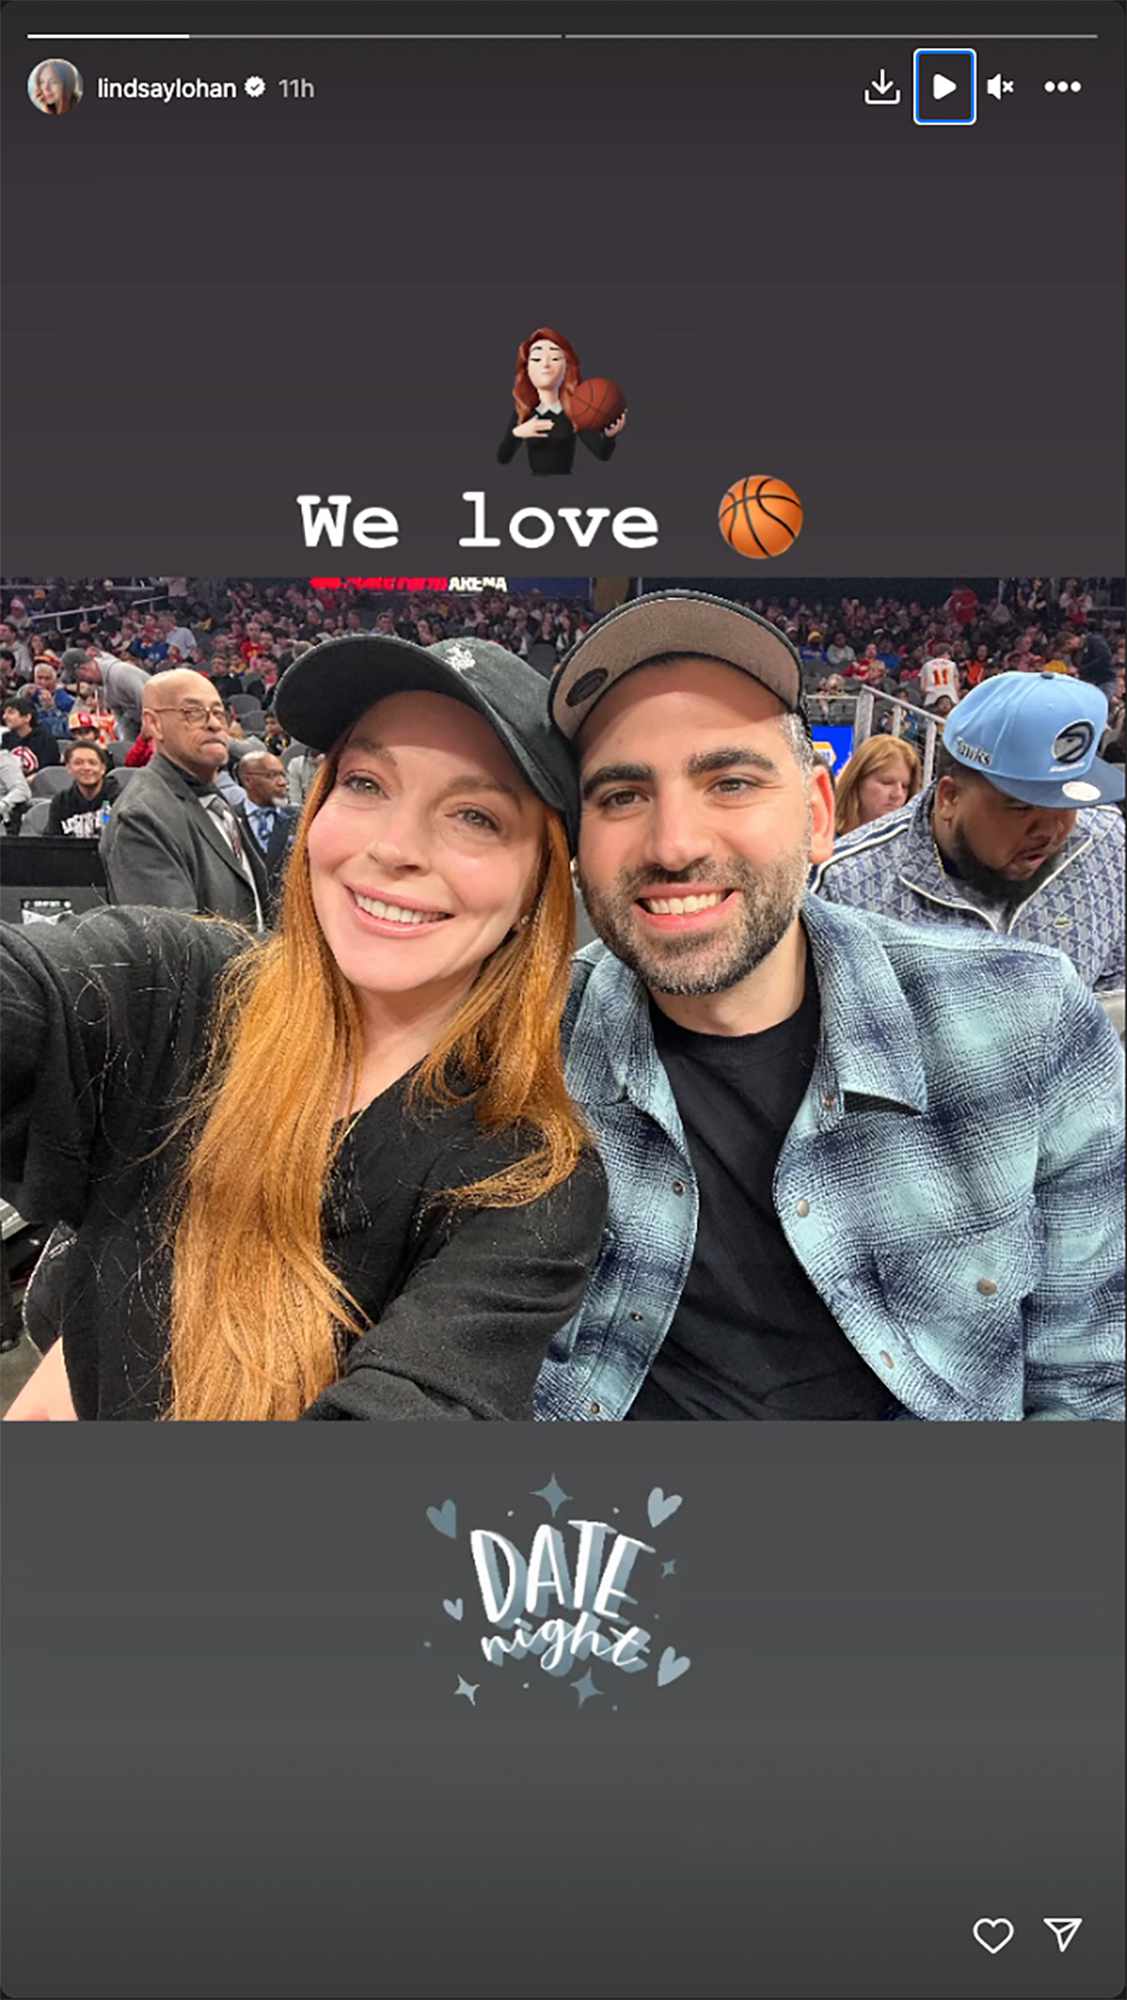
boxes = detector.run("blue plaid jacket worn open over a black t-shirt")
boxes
[536,896,1123,1422]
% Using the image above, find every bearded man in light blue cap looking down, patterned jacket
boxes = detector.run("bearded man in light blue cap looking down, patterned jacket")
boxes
[815,674,1125,992]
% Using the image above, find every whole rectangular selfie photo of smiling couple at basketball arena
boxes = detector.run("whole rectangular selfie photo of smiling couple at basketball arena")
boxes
[0,578,1125,1422]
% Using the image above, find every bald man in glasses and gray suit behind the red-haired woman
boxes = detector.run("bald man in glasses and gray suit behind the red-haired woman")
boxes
[102,668,268,930]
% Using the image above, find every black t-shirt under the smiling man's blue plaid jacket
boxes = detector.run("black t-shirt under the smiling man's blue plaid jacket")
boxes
[629,966,893,1422]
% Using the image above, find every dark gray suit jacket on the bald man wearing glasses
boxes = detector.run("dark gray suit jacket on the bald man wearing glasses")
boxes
[100,754,270,930]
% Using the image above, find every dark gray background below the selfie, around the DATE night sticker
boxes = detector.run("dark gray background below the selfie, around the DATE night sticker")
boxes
[4,1424,1123,2000]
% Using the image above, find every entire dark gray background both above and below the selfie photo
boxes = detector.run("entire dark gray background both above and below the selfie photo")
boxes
[0,0,1123,2000]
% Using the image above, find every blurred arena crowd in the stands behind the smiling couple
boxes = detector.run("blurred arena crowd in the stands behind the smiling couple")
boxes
[0,576,1125,838]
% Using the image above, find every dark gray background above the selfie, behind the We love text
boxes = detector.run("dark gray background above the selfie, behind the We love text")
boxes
[4,0,1123,576]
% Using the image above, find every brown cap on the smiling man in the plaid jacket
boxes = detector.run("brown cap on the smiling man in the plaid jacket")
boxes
[548,590,805,738]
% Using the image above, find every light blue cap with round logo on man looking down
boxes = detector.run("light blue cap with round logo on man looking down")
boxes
[943,674,1123,812]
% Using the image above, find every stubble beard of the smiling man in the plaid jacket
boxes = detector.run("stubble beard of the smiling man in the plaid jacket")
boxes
[575,814,813,1000]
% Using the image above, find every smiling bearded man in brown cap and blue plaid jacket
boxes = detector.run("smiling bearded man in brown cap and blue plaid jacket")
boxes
[536,592,1123,1422]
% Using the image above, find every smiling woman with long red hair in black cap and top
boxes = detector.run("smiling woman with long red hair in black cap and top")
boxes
[2,634,605,1420]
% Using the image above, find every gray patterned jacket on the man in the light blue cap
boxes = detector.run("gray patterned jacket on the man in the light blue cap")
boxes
[811,786,1125,990]
